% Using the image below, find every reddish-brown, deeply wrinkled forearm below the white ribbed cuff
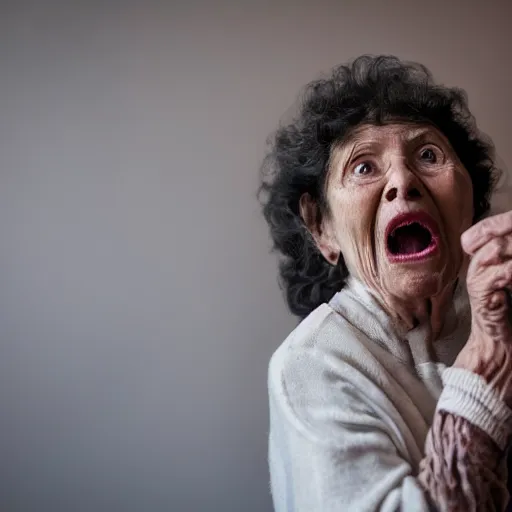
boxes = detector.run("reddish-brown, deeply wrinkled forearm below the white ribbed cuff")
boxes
[418,410,509,512]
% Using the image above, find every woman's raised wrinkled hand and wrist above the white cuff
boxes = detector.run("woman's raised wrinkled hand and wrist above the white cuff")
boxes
[454,211,512,407]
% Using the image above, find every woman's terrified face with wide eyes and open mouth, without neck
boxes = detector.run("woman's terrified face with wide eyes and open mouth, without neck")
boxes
[317,124,473,300]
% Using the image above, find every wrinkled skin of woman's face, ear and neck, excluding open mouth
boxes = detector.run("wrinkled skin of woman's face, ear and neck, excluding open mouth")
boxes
[301,123,473,337]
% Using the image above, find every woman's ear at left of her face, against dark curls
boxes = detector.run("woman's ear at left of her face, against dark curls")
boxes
[299,192,340,265]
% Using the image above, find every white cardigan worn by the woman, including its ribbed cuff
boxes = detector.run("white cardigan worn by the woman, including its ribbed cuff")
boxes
[268,279,512,512]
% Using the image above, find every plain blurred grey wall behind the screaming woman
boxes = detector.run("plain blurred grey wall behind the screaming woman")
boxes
[0,0,512,512]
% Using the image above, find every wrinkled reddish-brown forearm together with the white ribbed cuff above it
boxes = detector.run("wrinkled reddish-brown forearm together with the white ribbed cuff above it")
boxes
[418,368,512,512]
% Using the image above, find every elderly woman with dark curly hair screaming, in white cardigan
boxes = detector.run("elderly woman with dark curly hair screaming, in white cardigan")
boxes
[262,57,512,512]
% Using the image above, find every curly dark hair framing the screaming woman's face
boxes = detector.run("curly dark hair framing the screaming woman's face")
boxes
[259,55,500,318]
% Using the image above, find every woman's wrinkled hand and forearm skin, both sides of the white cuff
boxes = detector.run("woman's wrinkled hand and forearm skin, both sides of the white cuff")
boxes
[418,211,512,512]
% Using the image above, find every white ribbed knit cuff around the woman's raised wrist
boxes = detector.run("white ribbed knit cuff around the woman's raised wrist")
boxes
[436,368,512,450]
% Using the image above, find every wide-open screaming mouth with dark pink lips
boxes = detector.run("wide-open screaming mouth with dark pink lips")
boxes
[386,212,439,261]
